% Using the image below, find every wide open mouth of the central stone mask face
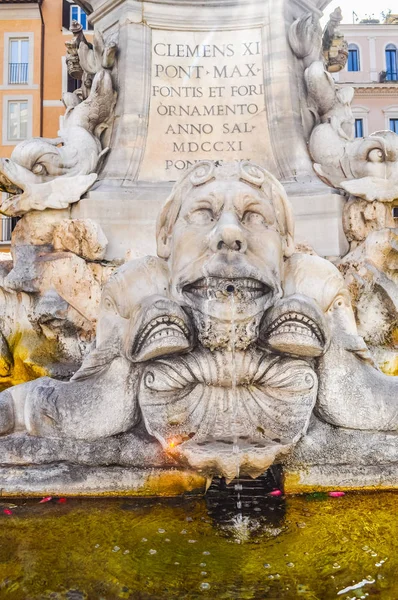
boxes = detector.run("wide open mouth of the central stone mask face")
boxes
[183,277,272,301]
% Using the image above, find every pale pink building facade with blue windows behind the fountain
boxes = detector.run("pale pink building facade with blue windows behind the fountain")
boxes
[335,15,398,137]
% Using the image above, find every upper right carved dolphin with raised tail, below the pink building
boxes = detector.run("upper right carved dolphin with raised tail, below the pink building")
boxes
[305,61,398,202]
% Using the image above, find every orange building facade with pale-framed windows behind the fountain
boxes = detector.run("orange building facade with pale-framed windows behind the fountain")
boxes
[0,0,90,244]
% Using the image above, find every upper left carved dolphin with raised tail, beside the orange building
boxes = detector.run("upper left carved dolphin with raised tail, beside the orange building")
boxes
[0,70,115,216]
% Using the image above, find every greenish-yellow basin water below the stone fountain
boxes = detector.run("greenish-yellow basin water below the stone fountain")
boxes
[0,493,398,600]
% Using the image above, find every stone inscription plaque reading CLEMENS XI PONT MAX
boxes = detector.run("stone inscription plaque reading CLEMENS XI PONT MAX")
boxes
[139,28,274,181]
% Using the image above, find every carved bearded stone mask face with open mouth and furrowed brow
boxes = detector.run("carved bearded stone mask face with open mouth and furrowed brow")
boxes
[170,180,283,328]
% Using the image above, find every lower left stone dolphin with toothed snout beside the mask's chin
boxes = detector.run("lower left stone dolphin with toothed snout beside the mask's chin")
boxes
[0,257,192,440]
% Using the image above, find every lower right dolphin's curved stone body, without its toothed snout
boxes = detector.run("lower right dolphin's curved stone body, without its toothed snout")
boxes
[285,254,398,431]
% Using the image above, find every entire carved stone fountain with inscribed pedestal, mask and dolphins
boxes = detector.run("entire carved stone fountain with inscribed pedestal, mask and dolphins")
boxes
[0,0,398,495]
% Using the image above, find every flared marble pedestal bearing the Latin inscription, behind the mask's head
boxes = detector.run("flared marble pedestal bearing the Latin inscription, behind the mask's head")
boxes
[72,0,348,260]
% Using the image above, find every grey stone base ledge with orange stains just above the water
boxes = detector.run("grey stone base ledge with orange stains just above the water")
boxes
[0,417,398,497]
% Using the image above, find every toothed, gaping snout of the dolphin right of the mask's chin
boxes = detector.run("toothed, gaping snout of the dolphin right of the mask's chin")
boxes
[259,294,329,358]
